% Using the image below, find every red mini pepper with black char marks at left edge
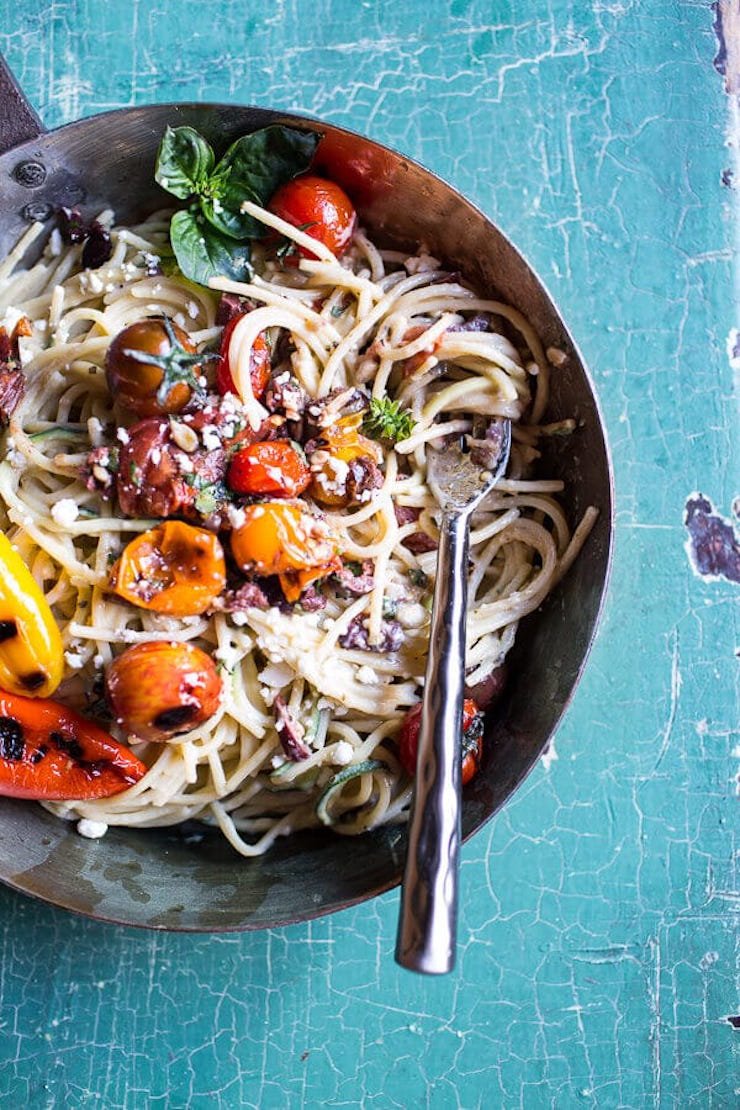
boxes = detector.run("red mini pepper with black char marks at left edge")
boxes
[0,690,146,801]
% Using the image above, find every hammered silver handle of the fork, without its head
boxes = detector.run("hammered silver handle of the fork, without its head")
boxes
[396,513,469,975]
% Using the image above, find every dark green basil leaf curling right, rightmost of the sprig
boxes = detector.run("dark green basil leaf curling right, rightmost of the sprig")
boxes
[201,124,321,239]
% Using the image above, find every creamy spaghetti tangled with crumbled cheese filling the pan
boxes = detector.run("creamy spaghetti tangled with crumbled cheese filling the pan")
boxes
[0,204,596,857]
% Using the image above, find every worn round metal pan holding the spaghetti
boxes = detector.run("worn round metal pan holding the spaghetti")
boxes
[0,65,612,931]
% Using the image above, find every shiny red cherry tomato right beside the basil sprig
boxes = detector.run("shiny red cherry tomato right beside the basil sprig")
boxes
[267,174,356,259]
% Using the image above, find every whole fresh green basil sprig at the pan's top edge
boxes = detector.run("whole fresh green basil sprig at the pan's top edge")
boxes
[154,124,321,285]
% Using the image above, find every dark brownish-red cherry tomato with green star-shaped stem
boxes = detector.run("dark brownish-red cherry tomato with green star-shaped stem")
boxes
[105,316,204,416]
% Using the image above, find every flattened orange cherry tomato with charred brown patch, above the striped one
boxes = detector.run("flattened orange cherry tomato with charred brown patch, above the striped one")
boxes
[110,521,226,617]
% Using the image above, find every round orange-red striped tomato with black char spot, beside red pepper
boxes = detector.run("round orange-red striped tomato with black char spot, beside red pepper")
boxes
[105,640,221,740]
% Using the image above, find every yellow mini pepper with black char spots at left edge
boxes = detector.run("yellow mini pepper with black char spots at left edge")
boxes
[0,534,64,697]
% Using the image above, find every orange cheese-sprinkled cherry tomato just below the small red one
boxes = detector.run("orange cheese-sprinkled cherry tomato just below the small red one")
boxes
[231,501,342,602]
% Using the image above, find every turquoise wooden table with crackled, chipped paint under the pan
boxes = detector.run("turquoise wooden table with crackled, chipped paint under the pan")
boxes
[0,0,740,1110]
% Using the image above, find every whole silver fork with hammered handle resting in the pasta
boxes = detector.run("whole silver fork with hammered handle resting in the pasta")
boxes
[396,420,511,975]
